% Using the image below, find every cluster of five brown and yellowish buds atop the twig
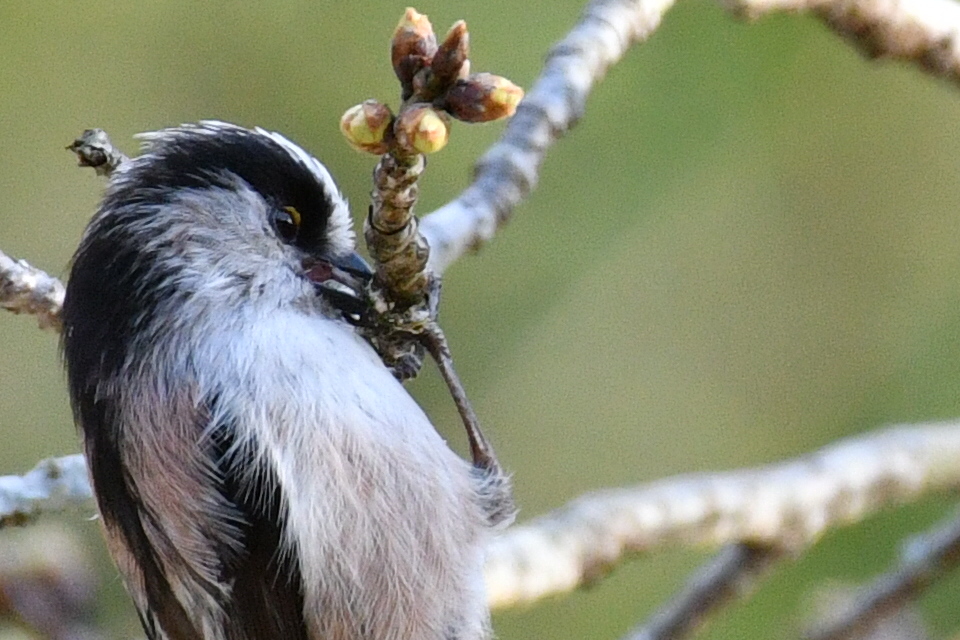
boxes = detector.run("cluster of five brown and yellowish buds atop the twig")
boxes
[340,8,523,155]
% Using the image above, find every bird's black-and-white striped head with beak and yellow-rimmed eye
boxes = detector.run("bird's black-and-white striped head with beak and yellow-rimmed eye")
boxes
[65,121,370,380]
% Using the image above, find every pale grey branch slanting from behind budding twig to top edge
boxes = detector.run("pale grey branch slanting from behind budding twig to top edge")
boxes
[420,0,673,274]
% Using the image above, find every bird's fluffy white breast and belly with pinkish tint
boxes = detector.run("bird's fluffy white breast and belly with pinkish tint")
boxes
[195,307,487,640]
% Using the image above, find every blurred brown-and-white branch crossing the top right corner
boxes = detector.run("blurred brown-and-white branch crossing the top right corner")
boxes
[721,0,960,82]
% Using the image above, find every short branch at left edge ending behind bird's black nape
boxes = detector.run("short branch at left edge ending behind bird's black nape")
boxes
[0,251,64,331]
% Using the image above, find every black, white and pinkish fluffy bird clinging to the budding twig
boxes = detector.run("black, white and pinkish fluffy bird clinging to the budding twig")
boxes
[62,121,510,640]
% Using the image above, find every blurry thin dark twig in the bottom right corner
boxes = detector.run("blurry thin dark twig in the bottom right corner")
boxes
[806,510,960,640]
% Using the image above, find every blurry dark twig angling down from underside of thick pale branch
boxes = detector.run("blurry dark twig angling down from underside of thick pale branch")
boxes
[624,543,785,640]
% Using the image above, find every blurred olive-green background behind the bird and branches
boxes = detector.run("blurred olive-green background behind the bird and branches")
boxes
[0,0,960,640]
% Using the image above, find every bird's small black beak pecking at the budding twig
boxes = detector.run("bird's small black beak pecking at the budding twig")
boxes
[303,251,373,325]
